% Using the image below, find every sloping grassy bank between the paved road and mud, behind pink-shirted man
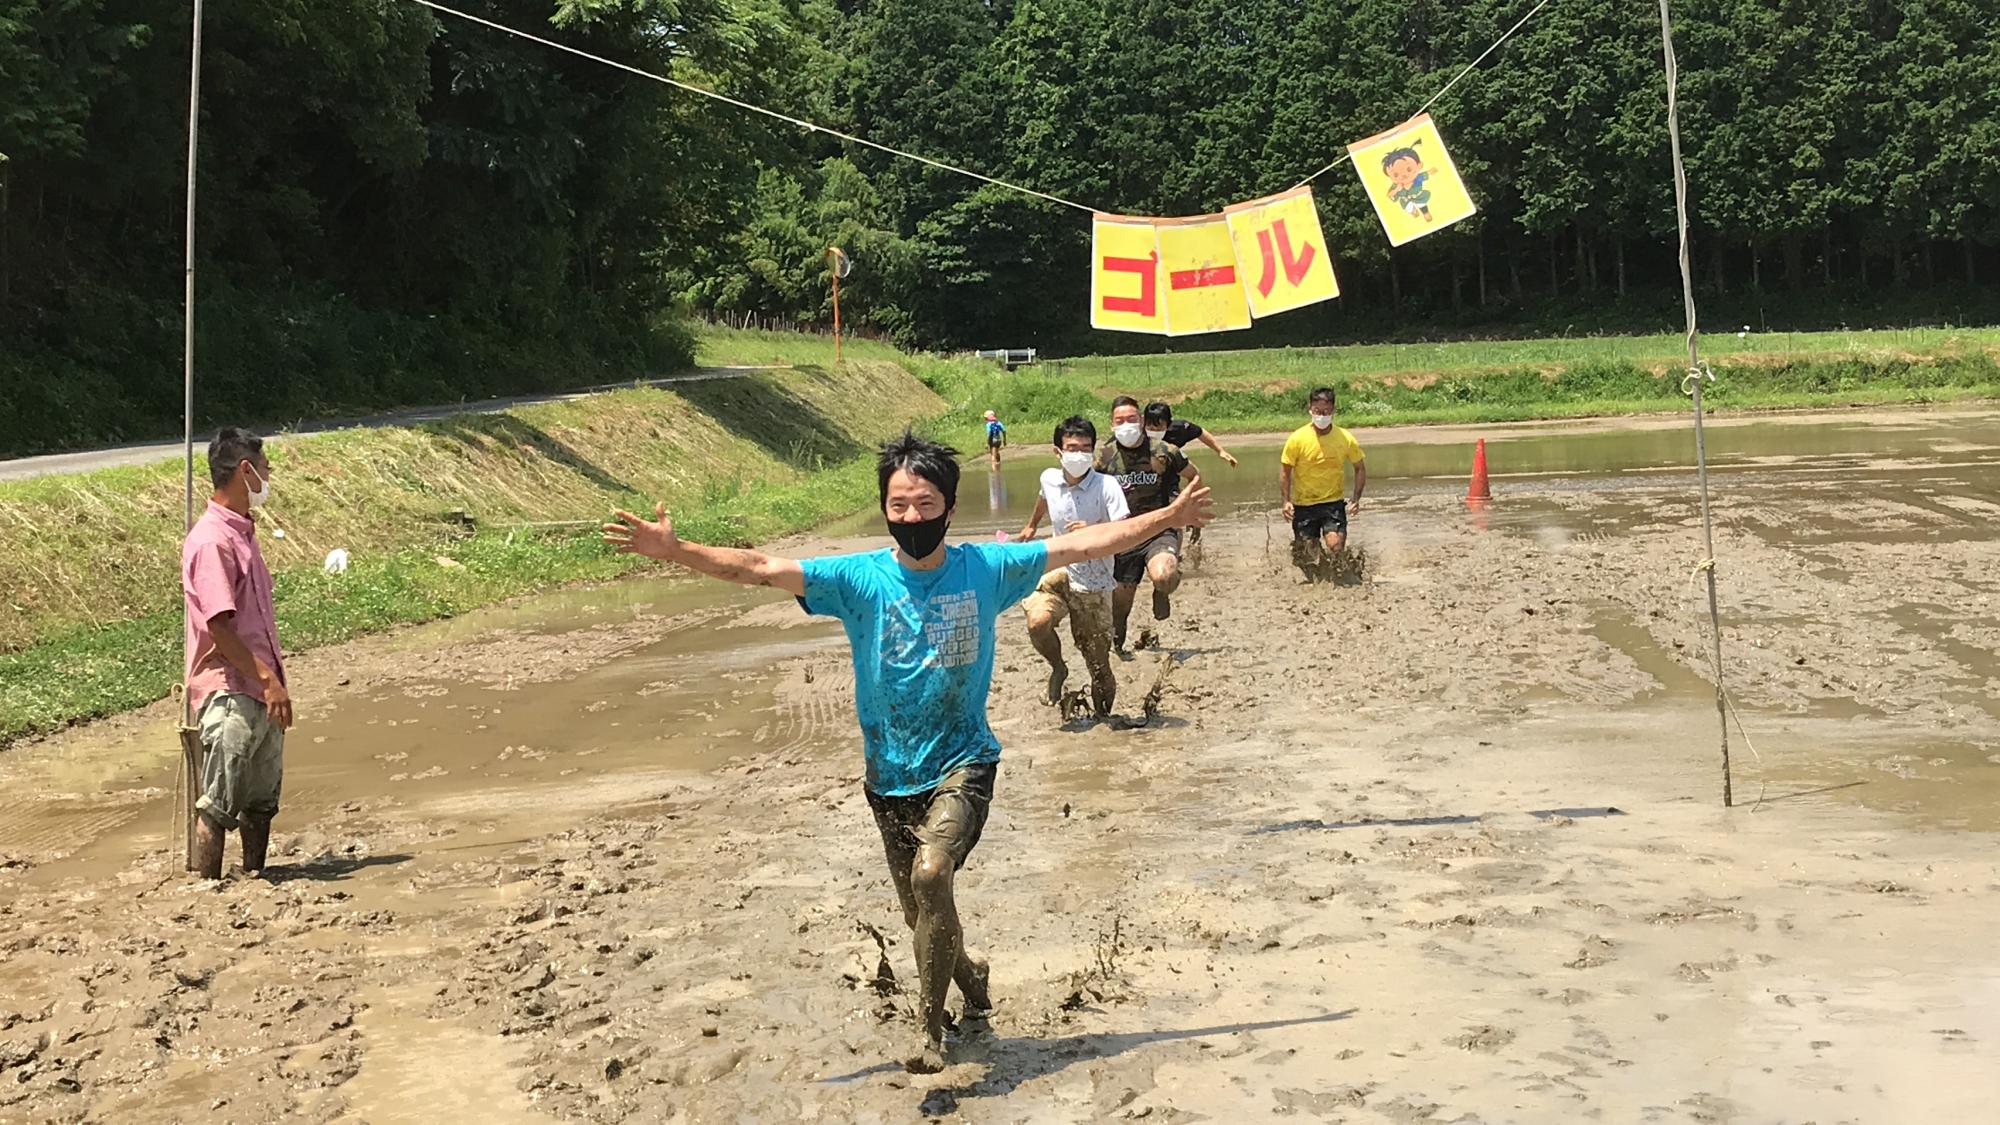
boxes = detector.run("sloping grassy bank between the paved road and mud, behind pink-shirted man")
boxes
[0,332,944,747]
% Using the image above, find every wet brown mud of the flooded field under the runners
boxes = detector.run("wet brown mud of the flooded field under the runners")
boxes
[0,406,2000,1123]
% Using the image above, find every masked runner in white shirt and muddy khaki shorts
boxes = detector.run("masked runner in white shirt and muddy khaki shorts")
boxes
[1020,416,1130,719]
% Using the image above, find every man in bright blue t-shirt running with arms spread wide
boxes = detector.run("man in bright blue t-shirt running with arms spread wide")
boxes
[604,430,1210,1073]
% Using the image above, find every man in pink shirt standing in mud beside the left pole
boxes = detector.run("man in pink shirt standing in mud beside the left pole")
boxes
[180,428,292,879]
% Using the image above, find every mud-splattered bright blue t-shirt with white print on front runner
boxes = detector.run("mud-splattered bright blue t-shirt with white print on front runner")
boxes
[798,542,1048,797]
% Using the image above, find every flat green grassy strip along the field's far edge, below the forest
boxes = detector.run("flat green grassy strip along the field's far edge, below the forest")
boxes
[938,328,2000,444]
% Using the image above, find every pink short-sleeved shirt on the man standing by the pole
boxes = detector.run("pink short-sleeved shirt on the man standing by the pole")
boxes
[180,500,286,713]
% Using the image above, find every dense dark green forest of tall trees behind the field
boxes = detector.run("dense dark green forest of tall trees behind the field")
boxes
[0,0,2000,450]
